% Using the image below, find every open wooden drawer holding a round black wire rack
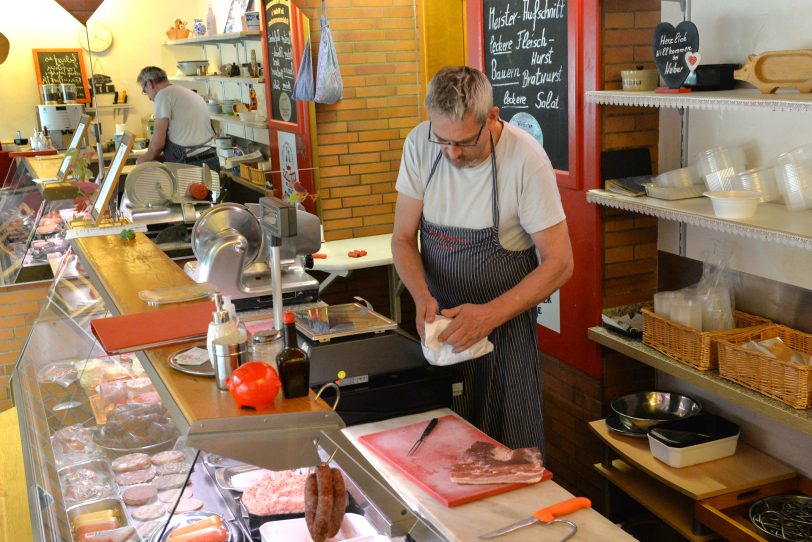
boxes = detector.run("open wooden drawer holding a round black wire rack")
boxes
[694,477,812,542]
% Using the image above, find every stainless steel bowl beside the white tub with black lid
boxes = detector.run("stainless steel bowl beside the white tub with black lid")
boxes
[612,391,702,431]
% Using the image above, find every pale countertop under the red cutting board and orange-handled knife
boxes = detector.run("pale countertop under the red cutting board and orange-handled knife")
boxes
[342,410,634,542]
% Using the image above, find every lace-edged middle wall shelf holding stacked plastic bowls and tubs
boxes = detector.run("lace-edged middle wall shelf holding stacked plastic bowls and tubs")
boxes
[586,189,812,250]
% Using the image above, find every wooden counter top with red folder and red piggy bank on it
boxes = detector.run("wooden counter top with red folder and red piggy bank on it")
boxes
[72,233,343,464]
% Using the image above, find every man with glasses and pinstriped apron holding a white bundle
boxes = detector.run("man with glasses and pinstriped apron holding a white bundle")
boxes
[392,67,573,449]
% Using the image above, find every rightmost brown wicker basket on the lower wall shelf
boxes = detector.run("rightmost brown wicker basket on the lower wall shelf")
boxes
[719,325,812,409]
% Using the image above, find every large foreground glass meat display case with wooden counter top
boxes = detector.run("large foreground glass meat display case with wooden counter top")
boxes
[12,243,444,542]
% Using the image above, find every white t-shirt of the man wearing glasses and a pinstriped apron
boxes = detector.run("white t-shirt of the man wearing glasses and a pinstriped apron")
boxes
[396,122,565,250]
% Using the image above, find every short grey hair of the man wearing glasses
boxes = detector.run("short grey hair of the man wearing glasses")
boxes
[425,66,493,122]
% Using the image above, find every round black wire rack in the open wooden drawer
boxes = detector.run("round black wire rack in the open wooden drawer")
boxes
[749,495,812,542]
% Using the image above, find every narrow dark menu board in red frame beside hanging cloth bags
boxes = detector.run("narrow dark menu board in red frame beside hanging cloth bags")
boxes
[265,0,297,123]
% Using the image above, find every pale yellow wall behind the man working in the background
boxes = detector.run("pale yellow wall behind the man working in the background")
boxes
[0,0,238,144]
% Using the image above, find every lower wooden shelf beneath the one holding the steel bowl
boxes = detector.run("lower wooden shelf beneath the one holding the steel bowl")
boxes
[594,459,719,542]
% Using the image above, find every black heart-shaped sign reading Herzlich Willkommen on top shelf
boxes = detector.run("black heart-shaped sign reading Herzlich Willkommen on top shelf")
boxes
[652,21,699,88]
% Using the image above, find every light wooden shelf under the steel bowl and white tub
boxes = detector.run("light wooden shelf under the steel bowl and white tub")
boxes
[589,420,797,501]
